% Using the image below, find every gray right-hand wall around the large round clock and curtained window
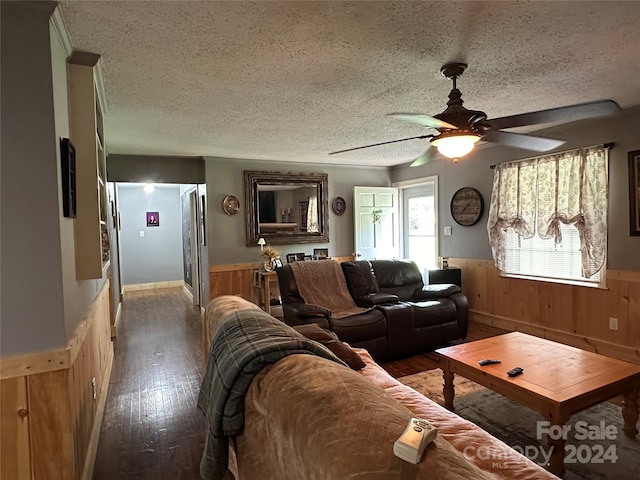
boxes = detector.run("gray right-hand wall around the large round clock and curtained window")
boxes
[391,106,640,271]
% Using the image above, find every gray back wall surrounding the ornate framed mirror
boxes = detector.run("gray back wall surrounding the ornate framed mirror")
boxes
[205,157,391,265]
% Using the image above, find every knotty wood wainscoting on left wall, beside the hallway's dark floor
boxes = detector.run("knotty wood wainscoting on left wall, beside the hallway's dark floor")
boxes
[0,282,113,480]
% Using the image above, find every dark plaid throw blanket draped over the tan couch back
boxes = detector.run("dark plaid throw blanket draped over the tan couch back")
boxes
[198,309,344,480]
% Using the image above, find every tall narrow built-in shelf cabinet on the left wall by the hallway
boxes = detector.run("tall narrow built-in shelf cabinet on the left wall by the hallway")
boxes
[67,52,110,279]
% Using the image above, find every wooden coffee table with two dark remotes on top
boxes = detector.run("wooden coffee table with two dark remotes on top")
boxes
[436,332,640,477]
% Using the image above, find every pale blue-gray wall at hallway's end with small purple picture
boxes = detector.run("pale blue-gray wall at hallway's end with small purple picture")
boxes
[116,183,183,285]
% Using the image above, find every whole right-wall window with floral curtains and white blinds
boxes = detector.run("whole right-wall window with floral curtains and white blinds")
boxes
[487,147,608,286]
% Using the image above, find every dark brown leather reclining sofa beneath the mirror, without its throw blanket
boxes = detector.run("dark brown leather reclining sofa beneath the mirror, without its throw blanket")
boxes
[277,260,468,360]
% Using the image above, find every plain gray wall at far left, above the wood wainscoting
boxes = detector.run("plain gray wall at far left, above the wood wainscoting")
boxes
[0,2,103,357]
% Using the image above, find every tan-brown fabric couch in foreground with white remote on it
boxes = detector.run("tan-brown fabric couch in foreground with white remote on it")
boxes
[199,297,556,480]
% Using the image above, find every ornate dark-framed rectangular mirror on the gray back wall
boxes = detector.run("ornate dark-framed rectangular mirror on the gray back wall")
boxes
[244,170,329,247]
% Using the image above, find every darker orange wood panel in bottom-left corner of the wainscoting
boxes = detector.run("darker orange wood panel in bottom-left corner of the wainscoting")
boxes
[0,377,31,480]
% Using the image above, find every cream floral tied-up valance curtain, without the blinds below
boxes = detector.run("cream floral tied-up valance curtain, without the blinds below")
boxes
[487,147,609,278]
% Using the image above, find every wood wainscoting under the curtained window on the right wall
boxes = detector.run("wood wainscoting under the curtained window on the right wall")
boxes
[449,258,640,363]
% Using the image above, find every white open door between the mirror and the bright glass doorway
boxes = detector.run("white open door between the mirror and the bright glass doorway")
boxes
[353,187,400,260]
